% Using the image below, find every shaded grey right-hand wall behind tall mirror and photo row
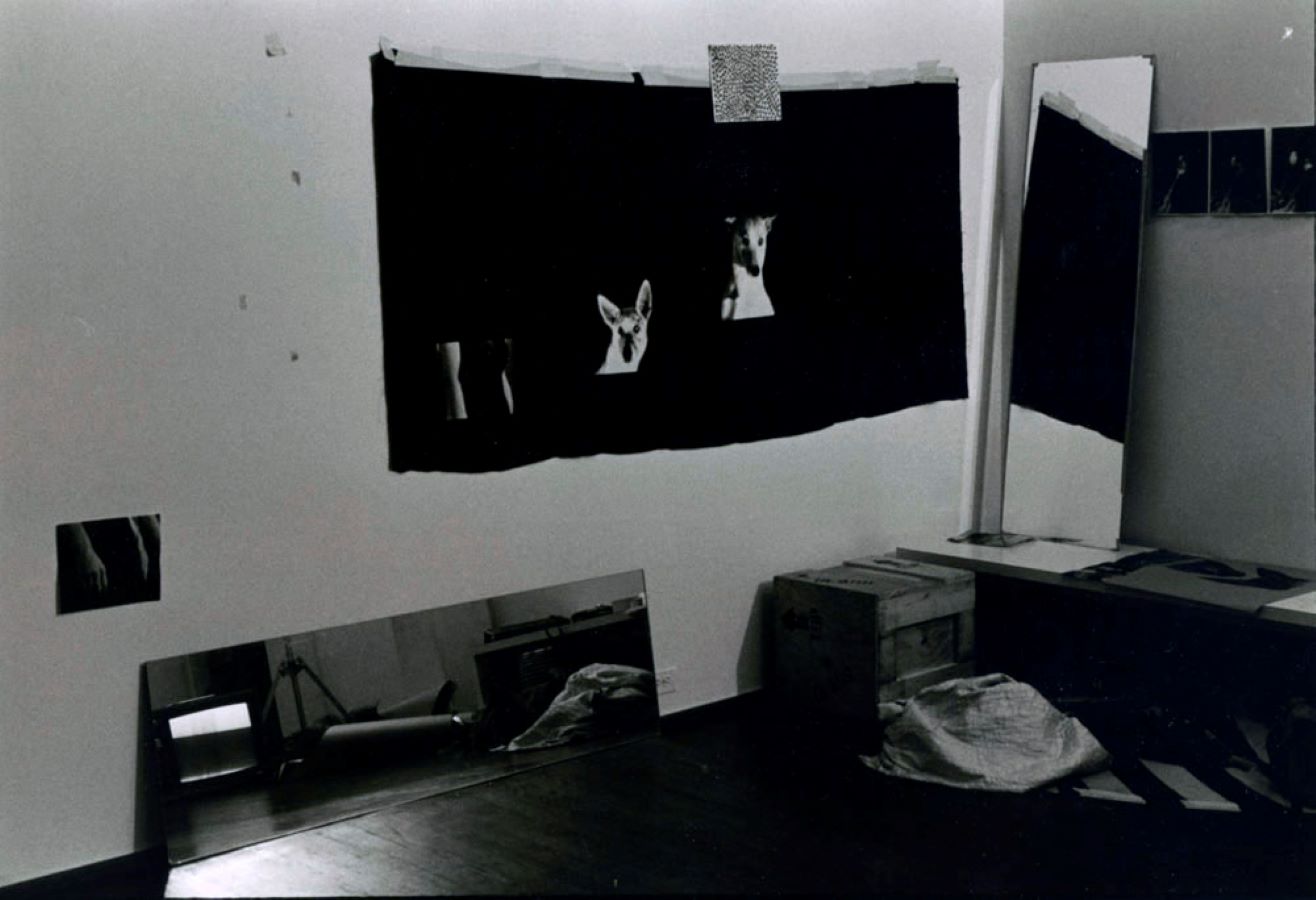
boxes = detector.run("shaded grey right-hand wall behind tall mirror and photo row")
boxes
[984,0,1316,566]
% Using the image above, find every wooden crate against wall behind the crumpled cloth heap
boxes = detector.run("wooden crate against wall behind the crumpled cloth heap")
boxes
[769,557,974,718]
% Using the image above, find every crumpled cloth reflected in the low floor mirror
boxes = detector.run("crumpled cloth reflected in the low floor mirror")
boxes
[507,663,657,750]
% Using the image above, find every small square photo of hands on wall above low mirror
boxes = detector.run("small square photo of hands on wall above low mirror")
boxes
[55,513,161,616]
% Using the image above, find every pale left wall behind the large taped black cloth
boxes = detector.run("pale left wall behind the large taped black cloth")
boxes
[0,0,1001,883]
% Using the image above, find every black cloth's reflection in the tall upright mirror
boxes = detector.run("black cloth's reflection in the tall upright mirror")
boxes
[1009,104,1142,443]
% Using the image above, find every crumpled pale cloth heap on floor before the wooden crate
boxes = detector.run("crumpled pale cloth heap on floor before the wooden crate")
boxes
[862,674,1111,792]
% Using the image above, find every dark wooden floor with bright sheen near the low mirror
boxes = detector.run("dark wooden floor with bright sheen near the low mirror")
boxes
[16,701,1316,896]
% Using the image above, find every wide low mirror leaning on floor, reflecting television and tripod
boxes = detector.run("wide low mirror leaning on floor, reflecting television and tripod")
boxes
[146,571,658,863]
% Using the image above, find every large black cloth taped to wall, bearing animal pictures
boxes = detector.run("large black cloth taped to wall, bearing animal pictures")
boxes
[372,55,967,471]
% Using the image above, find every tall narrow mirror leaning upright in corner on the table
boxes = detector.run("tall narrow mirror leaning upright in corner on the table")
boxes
[1003,57,1152,547]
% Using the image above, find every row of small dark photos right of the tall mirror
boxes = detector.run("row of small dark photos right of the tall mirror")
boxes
[1150,125,1316,216]
